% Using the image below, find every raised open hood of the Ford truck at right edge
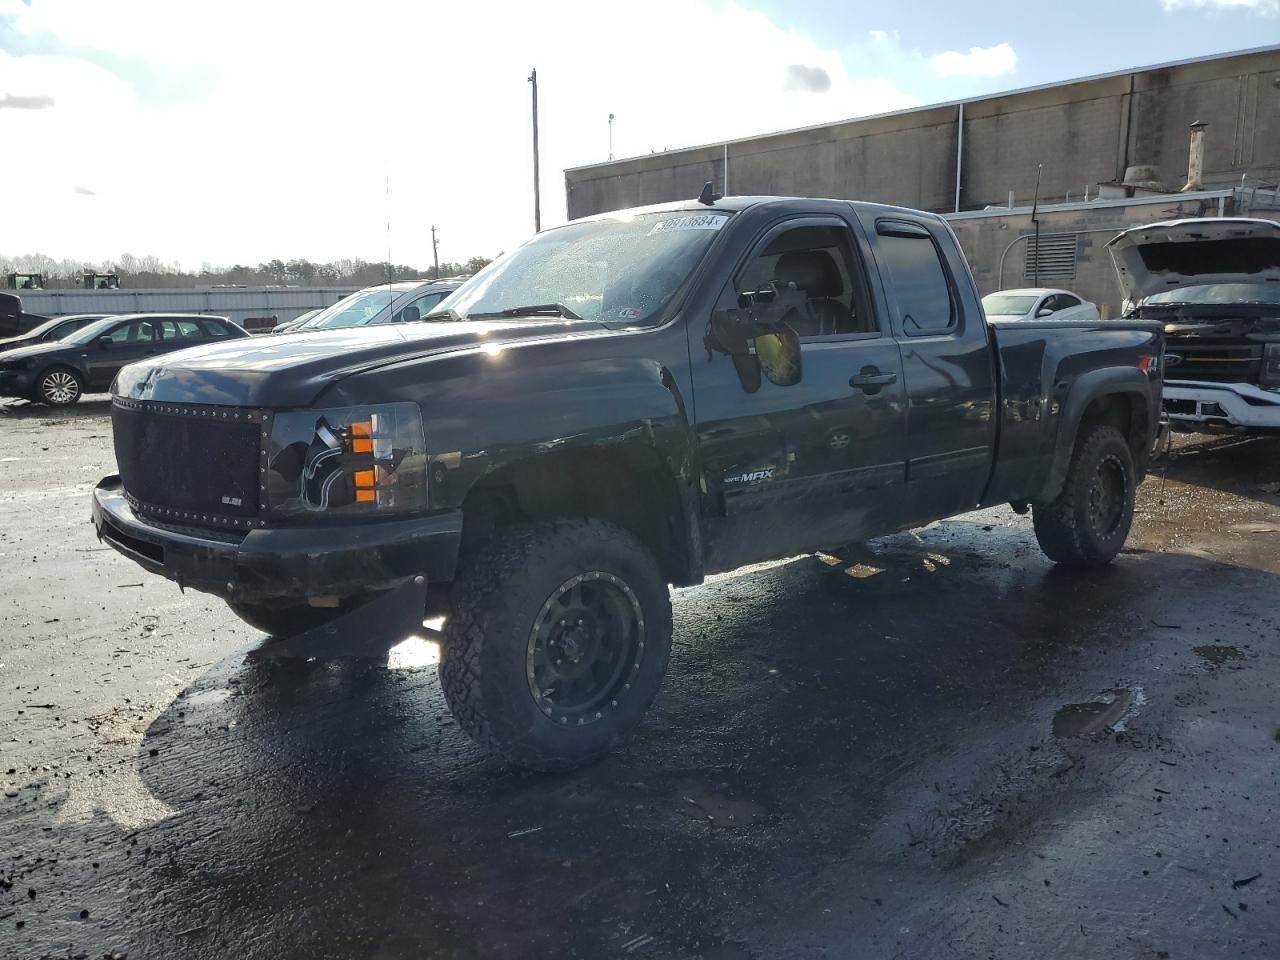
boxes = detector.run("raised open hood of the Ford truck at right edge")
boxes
[1107,218,1280,303]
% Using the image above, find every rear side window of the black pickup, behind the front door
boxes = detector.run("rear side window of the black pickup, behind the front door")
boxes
[876,224,956,337]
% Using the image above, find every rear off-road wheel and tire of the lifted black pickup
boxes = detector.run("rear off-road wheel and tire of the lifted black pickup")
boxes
[1032,424,1138,567]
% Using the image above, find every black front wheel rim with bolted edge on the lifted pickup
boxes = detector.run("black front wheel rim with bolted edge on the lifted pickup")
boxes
[525,571,644,726]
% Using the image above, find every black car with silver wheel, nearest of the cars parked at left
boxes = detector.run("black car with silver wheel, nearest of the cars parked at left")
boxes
[0,314,248,407]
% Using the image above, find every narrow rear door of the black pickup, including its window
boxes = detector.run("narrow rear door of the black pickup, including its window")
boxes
[861,210,996,522]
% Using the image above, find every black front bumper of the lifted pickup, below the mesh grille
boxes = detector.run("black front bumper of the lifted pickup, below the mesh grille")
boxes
[92,476,462,603]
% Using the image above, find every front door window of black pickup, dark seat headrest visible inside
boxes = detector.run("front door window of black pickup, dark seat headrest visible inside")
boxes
[739,224,878,338]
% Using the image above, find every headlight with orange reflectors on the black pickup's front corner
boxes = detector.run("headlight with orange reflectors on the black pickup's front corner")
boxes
[266,403,426,517]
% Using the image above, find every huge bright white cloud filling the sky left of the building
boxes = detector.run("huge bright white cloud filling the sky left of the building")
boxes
[0,0,918,271]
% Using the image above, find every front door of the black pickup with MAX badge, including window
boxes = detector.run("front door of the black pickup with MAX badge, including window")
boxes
[690,216,906,571]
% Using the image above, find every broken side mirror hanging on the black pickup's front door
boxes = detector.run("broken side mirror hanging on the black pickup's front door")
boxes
[704,287,805,393]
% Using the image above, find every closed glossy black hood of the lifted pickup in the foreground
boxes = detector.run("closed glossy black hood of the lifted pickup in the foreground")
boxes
[113,320,608,407]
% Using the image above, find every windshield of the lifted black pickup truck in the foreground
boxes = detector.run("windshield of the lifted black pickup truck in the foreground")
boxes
[442,211,728,325]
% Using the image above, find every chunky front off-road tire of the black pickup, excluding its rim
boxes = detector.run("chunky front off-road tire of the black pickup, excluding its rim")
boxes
[439,520,672,771]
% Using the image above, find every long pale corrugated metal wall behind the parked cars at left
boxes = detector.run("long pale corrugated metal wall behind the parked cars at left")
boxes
[14,287,358,325]
